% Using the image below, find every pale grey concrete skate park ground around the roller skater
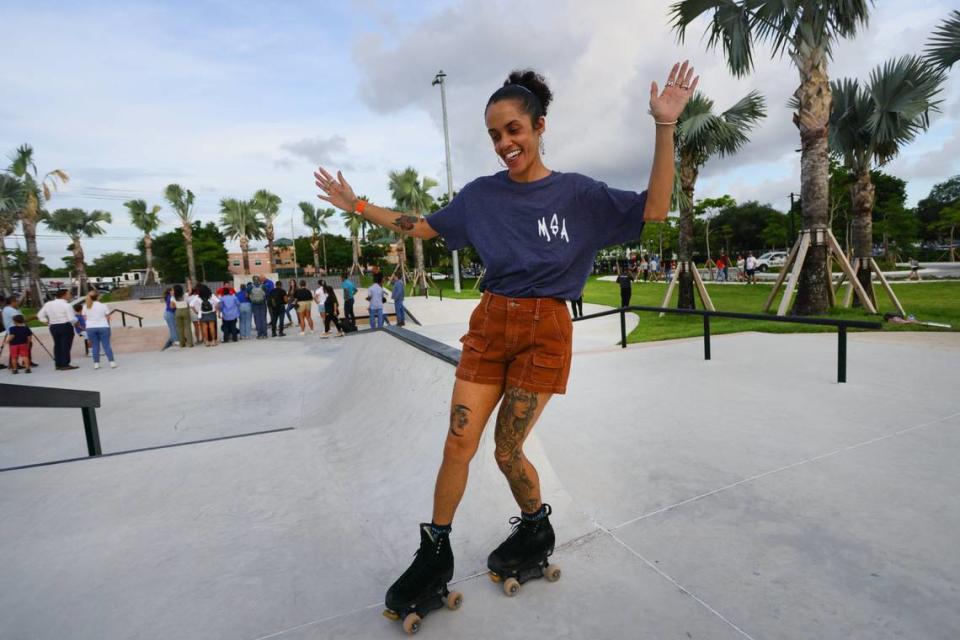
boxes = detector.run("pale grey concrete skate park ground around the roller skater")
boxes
[0,299,960,640]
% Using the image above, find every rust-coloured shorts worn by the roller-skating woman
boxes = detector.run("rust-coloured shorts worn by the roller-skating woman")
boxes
[457,291,573,393]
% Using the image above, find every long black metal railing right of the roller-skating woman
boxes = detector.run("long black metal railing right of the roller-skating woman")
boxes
[573,305,882,383]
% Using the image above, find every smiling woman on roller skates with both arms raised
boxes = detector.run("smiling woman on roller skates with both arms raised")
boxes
[314,62,698,613]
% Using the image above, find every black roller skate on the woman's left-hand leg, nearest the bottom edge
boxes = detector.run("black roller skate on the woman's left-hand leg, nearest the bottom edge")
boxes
[383,524,463,635]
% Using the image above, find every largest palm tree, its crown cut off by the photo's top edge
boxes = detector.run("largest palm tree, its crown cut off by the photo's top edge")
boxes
[670,0,872,315]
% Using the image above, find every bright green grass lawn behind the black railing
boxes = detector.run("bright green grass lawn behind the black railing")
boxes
[422,277,960,342]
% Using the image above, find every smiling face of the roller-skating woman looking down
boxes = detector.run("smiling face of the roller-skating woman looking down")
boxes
[486,100,549,182]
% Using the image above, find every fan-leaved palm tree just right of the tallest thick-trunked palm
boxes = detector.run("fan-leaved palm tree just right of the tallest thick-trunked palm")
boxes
[830,56,945,302]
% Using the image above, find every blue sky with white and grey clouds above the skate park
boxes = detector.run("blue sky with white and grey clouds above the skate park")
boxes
[0,0,960,266]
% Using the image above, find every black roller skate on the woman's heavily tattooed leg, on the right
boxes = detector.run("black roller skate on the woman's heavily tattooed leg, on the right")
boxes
[487,504,560,597]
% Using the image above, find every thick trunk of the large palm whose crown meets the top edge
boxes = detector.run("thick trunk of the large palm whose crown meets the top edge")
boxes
[793,44,832,315]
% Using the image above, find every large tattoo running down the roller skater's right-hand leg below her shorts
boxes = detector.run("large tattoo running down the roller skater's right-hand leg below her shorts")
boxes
[494,387,540,512]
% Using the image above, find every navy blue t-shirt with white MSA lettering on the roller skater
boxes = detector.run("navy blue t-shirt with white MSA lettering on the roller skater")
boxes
[427,171,647,300]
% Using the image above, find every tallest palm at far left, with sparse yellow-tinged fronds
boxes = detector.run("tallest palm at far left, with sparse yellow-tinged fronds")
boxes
[8,144,70,306]
